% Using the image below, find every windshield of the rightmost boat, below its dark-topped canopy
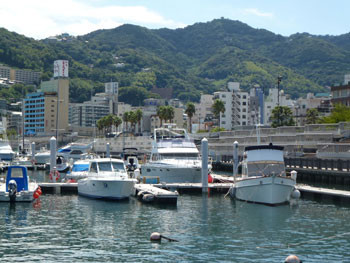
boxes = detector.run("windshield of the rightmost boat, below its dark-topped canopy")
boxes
[248,162,285,176]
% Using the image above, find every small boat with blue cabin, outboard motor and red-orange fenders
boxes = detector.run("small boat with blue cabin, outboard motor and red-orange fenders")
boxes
[0,165,41,202]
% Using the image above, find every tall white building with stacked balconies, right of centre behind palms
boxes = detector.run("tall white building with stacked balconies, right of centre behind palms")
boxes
[213,82,249,130]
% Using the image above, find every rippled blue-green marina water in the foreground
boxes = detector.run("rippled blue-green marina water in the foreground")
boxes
[0,172,350,262]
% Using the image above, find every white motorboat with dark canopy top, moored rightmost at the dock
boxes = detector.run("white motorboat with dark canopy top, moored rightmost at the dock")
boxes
[230,144,298,205]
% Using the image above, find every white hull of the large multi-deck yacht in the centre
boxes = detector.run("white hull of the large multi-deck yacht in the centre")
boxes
[141,163,202,183]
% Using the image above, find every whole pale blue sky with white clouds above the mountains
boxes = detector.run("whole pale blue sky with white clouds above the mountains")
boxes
[0,0,350,39]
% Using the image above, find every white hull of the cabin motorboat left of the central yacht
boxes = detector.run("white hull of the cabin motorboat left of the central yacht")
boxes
[78,178,137,200]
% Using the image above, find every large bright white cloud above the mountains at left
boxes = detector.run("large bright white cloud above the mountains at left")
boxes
[0,0,185,39]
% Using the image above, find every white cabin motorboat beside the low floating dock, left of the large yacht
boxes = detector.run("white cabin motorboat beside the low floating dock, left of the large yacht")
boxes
[78,158,137,200]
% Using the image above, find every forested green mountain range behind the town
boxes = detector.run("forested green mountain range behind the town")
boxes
[0,19,350,105]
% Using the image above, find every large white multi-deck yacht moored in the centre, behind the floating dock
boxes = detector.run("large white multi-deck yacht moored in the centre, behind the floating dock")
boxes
[141,128,211,183]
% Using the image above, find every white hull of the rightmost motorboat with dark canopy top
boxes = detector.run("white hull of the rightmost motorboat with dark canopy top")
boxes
[235,176,295,205]
